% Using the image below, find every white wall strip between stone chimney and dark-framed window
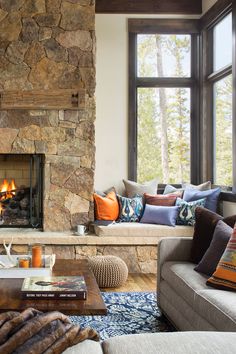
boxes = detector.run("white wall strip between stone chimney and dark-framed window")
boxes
[95,14,199,191]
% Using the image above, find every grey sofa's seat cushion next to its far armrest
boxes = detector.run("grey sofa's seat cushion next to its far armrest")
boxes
[161,262,210,306]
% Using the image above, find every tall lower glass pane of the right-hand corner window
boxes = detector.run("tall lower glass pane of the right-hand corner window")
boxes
[214,75,232,186]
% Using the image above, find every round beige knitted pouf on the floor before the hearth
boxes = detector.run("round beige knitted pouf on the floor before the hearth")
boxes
[89,256,128,288]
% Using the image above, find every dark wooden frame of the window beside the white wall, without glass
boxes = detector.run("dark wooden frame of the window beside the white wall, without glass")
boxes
[128,19,201,184]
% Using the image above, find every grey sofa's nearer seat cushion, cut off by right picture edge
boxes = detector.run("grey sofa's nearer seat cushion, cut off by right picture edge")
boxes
[194,289,236,330]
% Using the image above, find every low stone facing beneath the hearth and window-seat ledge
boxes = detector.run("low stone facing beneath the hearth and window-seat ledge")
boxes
[0,245,157,274]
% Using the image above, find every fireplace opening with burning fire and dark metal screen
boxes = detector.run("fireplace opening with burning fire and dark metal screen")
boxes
[0,154,44,228]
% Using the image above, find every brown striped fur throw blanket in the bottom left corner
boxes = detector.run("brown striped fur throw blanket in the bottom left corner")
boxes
[0,308,99,354]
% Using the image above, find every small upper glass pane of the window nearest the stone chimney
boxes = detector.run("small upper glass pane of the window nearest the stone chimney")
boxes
[137,34,191,77]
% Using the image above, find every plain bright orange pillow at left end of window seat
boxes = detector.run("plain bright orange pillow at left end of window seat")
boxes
[93,191,119,221]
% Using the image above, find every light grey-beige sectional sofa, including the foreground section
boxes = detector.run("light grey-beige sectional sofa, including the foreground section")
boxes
[65,237,236,354]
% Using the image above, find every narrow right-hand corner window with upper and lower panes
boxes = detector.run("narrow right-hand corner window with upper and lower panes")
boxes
[207,13,233,186]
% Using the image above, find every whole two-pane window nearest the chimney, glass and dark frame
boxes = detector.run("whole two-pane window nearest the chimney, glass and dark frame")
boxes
[129,20,199,183]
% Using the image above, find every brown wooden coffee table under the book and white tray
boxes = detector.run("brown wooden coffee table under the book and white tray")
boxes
[0,259,107,315]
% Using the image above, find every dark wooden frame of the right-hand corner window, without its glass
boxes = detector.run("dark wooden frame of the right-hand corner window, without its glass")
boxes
[200,0,236,202]
